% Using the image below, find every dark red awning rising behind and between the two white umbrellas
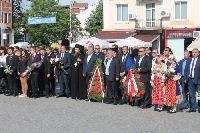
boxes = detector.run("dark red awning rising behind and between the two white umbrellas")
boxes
[93,31,135,40]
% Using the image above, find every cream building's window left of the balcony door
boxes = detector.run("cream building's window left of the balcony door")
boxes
[116,4,128,22]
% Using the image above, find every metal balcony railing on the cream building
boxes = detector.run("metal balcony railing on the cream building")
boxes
[135,19,162,29]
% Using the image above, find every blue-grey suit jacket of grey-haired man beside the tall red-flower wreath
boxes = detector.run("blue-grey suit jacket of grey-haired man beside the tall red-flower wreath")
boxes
[83,53,98,76]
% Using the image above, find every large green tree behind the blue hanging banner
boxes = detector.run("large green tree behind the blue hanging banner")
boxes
[23,0,80,45]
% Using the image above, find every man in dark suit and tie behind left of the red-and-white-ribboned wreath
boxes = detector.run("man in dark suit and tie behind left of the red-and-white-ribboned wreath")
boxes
[118,46,130,104]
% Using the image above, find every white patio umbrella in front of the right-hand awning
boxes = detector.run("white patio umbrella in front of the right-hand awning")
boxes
[115,37,149,47]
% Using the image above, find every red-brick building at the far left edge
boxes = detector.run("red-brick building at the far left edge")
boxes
[0,0,14,46]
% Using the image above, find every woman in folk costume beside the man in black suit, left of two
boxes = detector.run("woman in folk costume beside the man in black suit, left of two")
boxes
[151,55,167,112]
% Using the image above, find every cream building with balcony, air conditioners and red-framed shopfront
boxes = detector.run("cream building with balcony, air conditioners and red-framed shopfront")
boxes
[96,0,200,60]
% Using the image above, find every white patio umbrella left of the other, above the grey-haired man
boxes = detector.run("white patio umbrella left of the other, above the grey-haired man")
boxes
[70,37,110,48]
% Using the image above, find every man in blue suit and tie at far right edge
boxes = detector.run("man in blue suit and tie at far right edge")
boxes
[184,48,200,113]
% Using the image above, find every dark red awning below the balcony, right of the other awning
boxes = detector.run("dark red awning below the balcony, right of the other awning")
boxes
[134,34,159,42]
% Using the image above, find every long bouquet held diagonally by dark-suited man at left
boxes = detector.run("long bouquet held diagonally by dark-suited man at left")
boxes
[20,61,42,78]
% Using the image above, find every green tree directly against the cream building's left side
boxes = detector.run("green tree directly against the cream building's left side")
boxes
[85,0,103,35]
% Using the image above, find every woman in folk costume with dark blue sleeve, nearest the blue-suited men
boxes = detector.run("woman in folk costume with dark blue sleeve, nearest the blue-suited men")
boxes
[166,55,181,113]
